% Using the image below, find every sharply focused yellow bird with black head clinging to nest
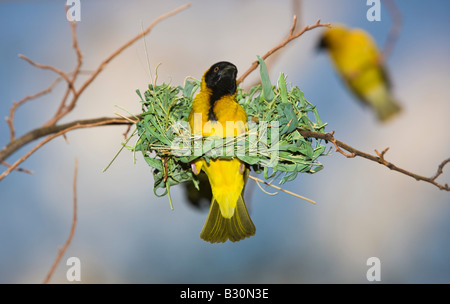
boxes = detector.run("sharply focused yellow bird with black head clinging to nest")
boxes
[189,61,256,243]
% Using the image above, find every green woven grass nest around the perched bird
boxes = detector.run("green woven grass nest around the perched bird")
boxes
[116,57,327,199]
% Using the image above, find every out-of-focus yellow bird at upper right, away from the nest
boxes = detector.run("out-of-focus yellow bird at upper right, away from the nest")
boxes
[319,25,401,122]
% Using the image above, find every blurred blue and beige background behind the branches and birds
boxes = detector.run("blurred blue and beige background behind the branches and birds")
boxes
[0,0,450,283]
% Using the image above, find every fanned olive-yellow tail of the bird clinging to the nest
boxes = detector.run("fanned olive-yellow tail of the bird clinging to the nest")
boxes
[200,195,256,243]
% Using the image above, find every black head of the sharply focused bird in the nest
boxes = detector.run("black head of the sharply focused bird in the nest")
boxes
[205,61,237,98]
